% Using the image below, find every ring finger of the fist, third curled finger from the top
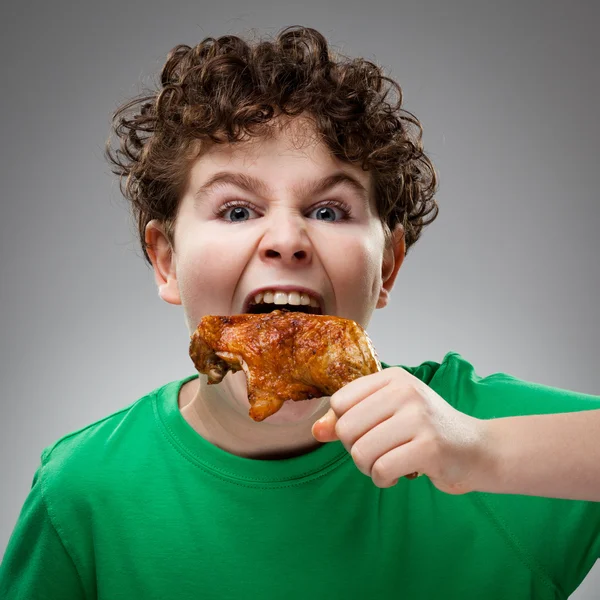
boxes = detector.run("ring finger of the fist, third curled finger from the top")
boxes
[350,413,416,477]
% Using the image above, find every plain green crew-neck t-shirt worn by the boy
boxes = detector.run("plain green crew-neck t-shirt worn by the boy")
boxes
[0,352,600,600]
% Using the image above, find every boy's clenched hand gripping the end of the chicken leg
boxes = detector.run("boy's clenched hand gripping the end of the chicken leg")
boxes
[312,367,487,494]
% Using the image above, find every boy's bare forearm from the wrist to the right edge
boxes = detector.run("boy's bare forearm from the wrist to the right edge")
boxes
[474,410,600,502]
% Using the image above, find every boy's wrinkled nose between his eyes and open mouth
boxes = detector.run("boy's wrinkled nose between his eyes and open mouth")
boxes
[259,214,312,266]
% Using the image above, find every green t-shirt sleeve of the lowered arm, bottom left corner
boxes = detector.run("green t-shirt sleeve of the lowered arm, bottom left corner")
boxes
[0,466,85,600]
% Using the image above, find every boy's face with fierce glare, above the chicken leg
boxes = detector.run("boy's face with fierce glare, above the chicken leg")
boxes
[146,119,404,424]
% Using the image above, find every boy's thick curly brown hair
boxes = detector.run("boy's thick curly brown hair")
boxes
[105,26,438,263]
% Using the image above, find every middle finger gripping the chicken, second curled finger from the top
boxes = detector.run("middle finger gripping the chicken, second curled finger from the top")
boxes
[335,386,402,452]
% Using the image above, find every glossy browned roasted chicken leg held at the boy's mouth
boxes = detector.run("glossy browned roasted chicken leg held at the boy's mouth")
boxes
[190,310,381,421]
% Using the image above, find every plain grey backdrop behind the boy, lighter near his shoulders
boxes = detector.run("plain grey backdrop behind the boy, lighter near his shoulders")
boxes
[0,0,600,600]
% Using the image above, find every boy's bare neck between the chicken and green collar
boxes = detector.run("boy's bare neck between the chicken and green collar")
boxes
[179,372,329,460]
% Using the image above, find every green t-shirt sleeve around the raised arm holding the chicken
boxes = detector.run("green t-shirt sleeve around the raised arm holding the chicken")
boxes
[442,353,600,596]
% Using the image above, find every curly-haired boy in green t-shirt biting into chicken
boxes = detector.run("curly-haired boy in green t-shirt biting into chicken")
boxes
[0,28,600,600]
